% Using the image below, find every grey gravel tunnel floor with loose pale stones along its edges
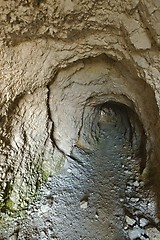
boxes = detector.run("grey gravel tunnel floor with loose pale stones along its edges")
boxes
[1,123,160,240]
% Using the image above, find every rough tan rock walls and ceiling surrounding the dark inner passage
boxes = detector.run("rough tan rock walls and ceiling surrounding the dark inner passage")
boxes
[0,0,160,231]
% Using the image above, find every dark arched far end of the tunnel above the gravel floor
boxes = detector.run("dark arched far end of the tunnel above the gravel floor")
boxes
[98,101,146,173]
